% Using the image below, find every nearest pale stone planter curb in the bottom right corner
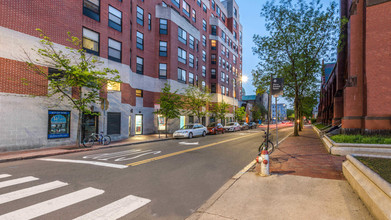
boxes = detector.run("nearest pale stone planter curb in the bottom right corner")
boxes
[342,155,391,219]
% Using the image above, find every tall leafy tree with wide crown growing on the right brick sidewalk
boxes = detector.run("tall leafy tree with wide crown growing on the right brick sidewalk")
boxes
[252,0,339,136]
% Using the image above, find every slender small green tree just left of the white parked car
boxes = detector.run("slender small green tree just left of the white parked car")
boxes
[155,83,183,137]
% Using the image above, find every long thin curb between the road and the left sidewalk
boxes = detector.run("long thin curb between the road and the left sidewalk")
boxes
[0,138,172,163]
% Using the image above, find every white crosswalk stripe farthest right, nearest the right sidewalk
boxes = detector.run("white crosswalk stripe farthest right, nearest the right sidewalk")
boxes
[74,195,151,220]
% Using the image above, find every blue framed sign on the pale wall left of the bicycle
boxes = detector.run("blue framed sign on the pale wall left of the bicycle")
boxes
[48,111,71,139]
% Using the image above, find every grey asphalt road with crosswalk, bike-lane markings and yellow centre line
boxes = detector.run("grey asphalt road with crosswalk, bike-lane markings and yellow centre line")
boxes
[0,128,292,220]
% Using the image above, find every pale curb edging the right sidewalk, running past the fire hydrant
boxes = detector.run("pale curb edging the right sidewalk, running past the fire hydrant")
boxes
[185,129,293,220]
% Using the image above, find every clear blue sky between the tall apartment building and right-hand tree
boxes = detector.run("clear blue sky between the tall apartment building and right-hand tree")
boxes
[236,0,333,105]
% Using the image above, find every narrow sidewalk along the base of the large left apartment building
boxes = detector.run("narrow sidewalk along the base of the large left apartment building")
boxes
[0,134,172,163]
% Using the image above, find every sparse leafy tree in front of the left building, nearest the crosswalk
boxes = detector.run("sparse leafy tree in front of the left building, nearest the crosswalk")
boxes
[25,29,121,147]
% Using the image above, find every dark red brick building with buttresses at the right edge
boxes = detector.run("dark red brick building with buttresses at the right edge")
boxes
[318,0,391,134]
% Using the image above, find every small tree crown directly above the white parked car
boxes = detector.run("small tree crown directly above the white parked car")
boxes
[184,86,212,122]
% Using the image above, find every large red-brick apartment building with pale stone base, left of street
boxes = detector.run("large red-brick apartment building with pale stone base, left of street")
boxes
[0,0,242,151]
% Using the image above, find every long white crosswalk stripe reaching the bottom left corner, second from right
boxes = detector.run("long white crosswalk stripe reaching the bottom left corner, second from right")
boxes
[0,187,105,220]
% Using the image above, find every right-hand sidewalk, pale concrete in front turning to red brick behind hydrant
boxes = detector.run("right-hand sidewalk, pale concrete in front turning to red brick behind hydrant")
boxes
[188,127,373,220]
